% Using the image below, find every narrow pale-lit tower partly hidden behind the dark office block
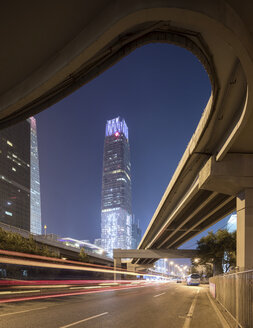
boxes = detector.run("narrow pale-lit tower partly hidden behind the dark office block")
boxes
[30,117,41,235]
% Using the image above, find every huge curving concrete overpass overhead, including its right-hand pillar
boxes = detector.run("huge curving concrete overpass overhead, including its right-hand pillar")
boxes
[0,0,253,268]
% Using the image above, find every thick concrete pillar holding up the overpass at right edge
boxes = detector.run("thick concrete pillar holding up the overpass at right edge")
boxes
[236,189,253,270]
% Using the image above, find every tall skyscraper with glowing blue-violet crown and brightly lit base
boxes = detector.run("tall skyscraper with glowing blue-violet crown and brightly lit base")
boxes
[101,117,132,256]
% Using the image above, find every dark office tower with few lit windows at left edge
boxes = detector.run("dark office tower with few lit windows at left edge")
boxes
[0,121,30,231]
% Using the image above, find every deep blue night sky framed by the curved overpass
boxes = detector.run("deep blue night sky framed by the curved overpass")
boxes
[36,44,233,248]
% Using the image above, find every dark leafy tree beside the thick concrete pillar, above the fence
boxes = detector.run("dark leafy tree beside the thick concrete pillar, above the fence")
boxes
[192,230,236,274]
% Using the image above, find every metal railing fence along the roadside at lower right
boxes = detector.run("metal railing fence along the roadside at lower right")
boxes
[210,270,253,328]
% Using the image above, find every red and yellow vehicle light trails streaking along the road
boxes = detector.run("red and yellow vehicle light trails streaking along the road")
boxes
[0,250,170,303]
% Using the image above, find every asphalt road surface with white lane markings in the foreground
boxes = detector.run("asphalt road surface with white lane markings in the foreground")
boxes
[0,282,223,328]
